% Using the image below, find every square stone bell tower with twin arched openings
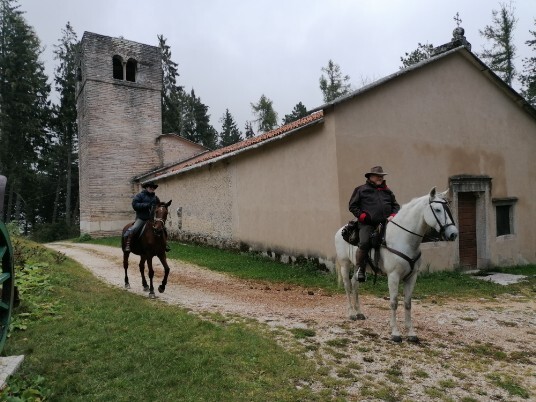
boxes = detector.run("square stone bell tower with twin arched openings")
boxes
[76,32,162,236]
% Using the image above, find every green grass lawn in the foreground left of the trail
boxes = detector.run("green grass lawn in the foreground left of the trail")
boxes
[0,239,320,401]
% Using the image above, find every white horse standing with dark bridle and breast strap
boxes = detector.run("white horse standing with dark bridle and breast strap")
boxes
[335,187,458,342]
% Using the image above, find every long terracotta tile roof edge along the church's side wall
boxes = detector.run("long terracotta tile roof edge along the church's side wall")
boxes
[155,110,324,179]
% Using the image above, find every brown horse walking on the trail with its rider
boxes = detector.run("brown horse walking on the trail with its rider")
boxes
[121,200,171,299]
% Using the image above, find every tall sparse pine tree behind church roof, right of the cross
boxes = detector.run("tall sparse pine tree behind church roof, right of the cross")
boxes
[479,3,517,85]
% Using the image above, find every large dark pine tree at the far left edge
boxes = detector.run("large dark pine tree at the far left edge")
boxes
[0,0,50,224]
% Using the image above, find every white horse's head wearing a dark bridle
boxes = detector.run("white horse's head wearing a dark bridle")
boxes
[424,187,458,241]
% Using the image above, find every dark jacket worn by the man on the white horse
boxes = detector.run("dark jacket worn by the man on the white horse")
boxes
[348,180,400,226]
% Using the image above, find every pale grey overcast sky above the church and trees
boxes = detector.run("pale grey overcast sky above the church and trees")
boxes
[19,0,536,131]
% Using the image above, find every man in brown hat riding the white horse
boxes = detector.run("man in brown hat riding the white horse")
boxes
[349,166,400,282]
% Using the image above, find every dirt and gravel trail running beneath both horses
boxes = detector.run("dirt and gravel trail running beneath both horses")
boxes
[47,243,536,401]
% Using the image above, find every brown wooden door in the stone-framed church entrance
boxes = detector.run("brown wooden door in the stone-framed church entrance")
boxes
[458,193,478,268]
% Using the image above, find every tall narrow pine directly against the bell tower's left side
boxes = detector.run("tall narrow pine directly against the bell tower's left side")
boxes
[53,22,79,225]
